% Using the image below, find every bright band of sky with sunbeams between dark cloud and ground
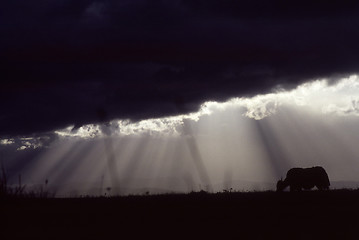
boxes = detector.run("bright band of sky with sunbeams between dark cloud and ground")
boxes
[0,75,359,194]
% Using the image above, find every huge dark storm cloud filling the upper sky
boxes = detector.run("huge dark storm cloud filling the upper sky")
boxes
[0,0,359,135]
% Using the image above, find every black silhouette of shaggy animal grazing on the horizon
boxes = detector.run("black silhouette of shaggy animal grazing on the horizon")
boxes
[277,167,330,192]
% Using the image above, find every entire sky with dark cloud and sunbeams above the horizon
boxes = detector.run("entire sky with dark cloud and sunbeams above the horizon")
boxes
[0,0,359,194]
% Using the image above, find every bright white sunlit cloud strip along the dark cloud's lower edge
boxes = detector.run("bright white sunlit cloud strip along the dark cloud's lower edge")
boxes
[50,75,359,139]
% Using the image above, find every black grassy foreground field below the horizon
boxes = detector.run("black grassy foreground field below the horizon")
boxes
[0,190,359,239]
